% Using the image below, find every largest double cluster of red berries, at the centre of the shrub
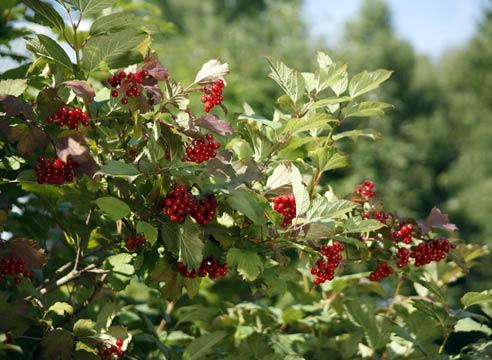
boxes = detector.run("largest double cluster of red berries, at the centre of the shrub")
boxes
[162,185,218,224]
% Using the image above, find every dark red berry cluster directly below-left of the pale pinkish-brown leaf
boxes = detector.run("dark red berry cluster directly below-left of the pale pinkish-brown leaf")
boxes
[36,156,77,185]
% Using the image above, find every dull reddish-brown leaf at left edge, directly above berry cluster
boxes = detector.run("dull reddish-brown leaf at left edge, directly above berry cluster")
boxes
[0,237,46,269]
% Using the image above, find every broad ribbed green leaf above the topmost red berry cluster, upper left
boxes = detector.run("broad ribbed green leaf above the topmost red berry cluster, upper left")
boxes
[82,29,148,72]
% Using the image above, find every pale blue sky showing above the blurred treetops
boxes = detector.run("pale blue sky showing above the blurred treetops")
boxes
[304,0,488,58]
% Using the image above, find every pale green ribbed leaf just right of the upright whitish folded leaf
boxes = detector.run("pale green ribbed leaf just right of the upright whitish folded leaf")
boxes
[306,196,356,223]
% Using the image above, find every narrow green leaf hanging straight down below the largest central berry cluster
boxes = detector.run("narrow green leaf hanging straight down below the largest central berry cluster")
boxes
[178,217,204,269]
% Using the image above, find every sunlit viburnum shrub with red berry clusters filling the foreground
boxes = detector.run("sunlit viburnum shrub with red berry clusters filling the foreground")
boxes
[0,0,492,360]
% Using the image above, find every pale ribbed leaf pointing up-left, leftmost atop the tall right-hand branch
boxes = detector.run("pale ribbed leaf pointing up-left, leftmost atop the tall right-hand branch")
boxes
[267,57,304,104]
